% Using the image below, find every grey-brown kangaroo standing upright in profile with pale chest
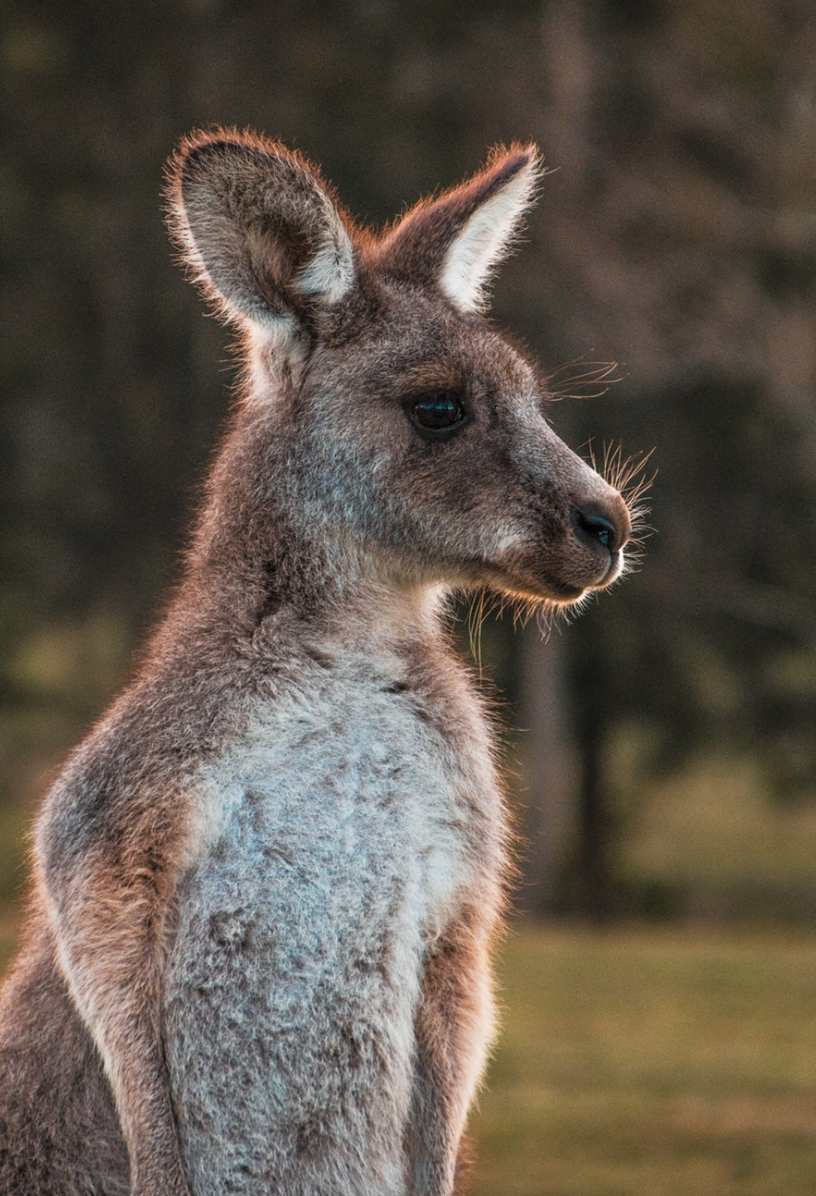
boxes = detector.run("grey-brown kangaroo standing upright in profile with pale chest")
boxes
[0,129,631,1196]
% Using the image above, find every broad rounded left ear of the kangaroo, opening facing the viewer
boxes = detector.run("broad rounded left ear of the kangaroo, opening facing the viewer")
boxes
[169,130,355,338]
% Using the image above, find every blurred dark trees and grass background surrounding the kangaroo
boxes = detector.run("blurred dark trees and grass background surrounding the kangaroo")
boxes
[0,0,816,1196]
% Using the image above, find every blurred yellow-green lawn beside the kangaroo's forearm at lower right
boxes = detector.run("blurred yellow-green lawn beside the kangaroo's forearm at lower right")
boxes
[471,928,816,1196]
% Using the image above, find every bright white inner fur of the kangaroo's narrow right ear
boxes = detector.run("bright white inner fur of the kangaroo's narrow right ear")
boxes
[439,159,540,311]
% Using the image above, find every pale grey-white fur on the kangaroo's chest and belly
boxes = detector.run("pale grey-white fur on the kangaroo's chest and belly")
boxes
[165,669,501,1192]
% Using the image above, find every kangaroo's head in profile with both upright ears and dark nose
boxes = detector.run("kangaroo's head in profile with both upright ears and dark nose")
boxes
[171,130,631,603]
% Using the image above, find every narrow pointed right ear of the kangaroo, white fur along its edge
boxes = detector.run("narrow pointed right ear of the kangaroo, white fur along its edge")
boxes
[378,146,541,311]
